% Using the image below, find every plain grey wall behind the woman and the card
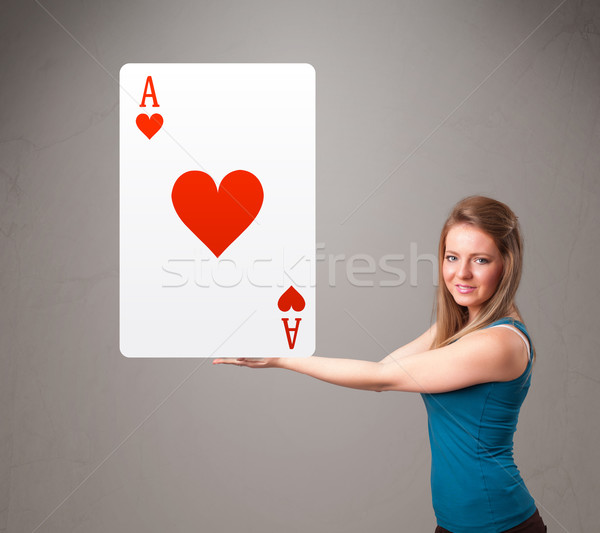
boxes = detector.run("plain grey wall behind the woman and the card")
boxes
[0,0,600,533]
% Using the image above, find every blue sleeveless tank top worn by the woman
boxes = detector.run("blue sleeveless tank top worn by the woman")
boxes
[421,318,536,533]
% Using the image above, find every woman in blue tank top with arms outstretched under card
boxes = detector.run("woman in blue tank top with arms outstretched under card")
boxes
[213,196,546,533]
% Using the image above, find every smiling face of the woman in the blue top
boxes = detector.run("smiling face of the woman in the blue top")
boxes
[442,224,503,321]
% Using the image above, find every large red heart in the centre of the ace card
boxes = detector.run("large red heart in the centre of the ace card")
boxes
[171,170,263,257]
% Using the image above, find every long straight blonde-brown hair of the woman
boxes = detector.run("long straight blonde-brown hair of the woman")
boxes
[431,196,535,357]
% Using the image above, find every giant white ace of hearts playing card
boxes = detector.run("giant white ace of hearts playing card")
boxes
[119,63,316,357]
